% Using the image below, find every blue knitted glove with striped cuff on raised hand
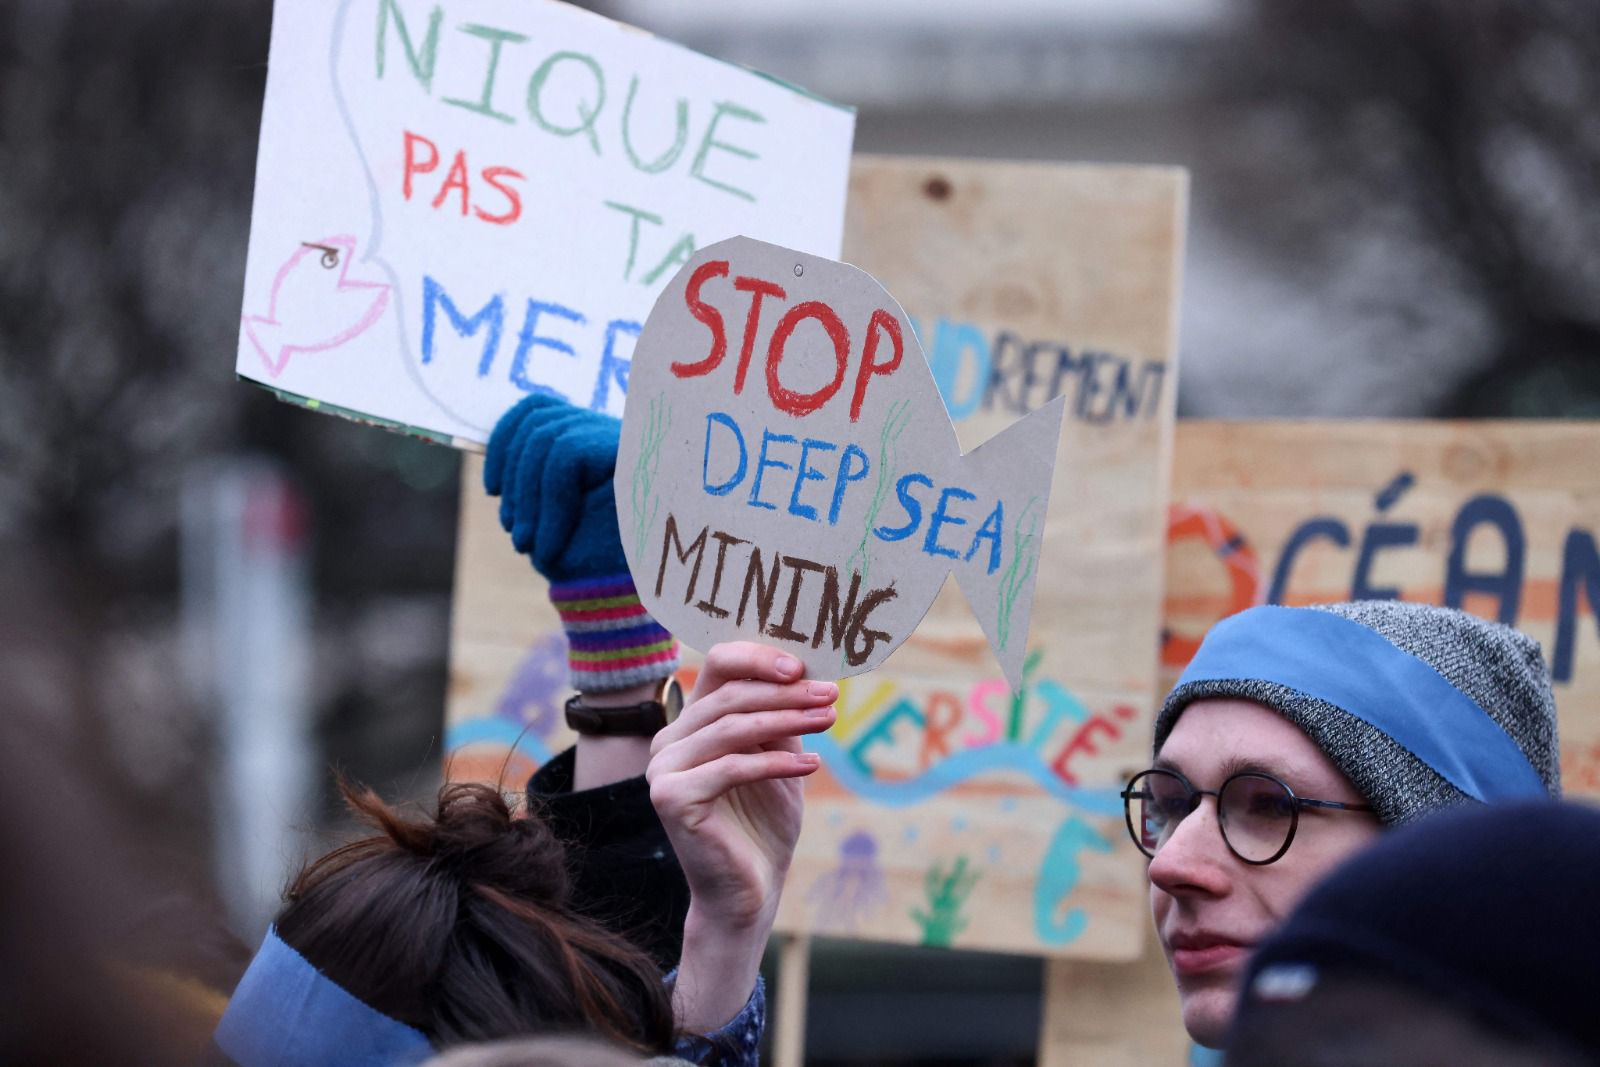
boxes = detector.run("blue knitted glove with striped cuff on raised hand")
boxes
[483,395,678,691]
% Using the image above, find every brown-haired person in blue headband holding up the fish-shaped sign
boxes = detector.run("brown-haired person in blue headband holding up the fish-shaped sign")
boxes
[216,643,838,1067]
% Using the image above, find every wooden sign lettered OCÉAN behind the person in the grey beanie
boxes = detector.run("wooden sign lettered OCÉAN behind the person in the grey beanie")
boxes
[1042,421,1600,1067]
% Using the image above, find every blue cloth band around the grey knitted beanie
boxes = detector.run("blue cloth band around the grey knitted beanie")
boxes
[1178,606,1547,801]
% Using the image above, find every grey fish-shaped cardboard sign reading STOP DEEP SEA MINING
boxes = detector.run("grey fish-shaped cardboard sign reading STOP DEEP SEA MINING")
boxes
[616,237,1062,689]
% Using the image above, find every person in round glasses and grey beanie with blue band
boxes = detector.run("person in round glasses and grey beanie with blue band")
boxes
[1123,601,1560,1048]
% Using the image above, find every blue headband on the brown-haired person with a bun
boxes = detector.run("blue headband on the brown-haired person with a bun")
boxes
[216,929,434,1067]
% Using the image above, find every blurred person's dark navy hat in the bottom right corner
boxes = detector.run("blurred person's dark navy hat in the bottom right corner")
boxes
[1226,803,1600,1067]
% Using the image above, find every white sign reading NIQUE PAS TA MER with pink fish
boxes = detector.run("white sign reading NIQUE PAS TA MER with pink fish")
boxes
[237,0,854,443]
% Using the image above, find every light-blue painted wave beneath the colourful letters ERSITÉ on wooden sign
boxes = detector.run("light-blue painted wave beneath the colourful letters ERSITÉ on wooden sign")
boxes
[805,734,1122,816]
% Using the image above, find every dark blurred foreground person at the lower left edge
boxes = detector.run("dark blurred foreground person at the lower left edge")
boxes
[0,553,250,1067]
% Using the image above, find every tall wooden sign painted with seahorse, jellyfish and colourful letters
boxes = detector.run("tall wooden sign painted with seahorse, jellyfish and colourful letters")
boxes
[446,158,1186,960]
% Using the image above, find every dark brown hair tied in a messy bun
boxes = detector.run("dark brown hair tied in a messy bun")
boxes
[277,781,674,1053]
